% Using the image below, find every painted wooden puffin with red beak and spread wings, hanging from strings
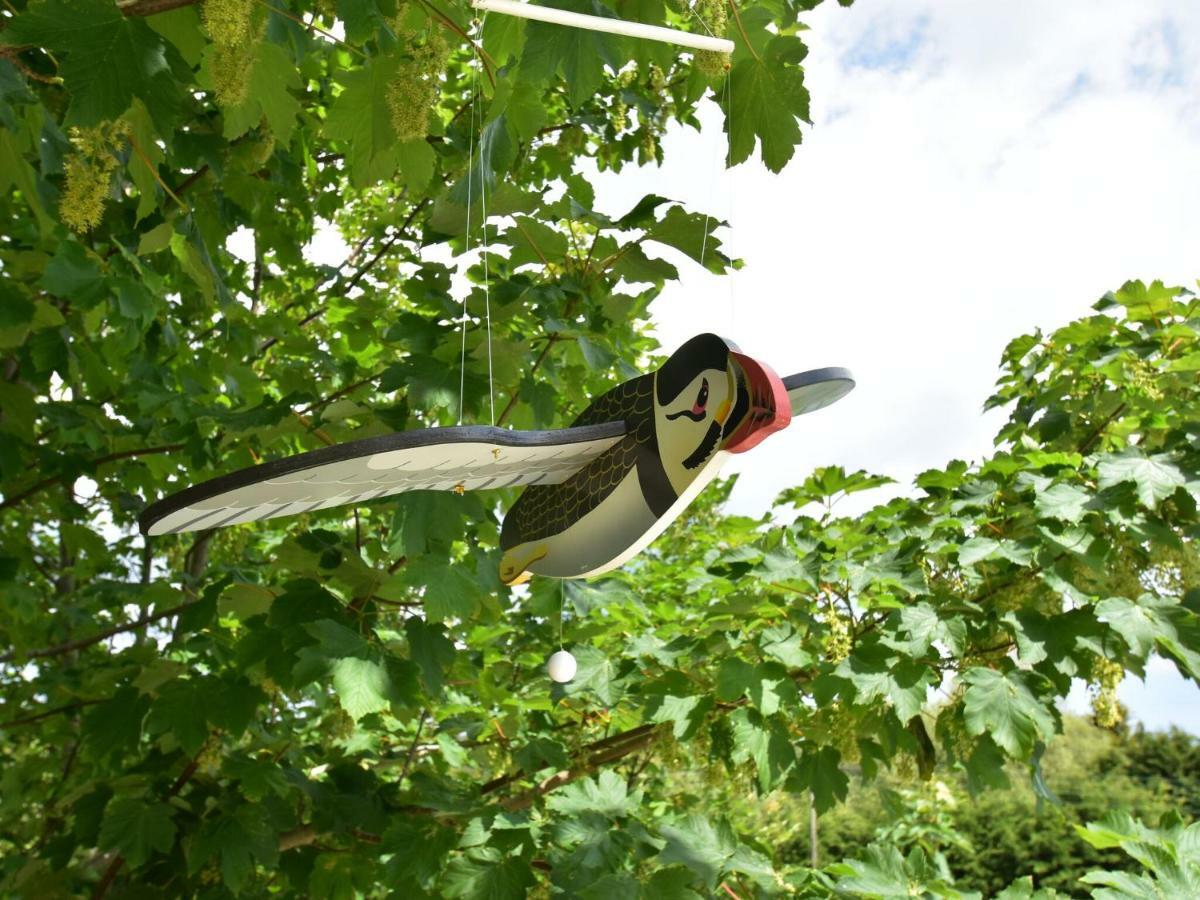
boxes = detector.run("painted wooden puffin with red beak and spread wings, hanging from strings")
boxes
[139,334,854,584]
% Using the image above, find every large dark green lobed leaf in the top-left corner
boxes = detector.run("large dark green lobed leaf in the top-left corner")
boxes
[2,0,184,127]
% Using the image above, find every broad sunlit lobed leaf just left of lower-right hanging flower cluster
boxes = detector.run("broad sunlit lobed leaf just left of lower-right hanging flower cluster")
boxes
[962,666,1055,760]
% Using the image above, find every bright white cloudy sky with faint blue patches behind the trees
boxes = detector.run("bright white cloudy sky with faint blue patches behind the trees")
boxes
[573,0,1200,733]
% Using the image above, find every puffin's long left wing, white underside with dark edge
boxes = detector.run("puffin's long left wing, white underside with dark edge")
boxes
[139,421,625,534]
